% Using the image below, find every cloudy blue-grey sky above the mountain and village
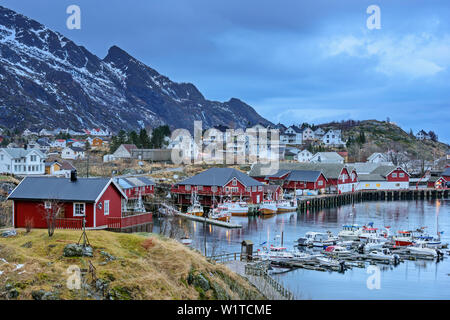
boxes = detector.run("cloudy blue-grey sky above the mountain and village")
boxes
[0,0,450,143]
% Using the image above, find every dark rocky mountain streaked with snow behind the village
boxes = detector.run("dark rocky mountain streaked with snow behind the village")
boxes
[0,6,270,132]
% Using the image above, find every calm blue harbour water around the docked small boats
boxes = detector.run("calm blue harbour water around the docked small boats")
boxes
[155,200,450,299]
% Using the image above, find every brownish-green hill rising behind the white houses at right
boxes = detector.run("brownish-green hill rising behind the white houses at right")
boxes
[321,120,449,160]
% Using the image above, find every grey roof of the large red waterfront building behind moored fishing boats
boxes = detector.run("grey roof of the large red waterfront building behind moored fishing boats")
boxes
[177,168,263,187]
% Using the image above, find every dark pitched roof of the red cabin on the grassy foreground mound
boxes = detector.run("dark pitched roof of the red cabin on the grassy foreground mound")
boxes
[8,177,122,202]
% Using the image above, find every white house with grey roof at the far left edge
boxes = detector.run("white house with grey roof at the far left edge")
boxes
[0,148,45,175]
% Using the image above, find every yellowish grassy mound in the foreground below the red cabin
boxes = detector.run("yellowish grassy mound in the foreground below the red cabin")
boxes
[0,229,264,300]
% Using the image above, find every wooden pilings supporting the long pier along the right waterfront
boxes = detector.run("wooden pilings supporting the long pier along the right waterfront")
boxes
[298,189,450,211]
